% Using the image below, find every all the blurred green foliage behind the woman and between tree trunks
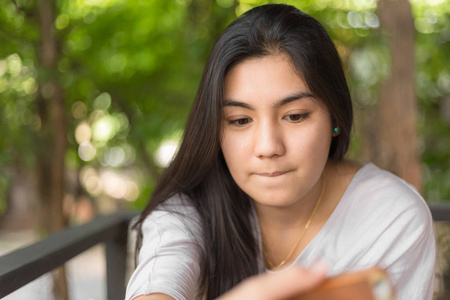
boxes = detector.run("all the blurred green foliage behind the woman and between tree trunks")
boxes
[0,0,450,216]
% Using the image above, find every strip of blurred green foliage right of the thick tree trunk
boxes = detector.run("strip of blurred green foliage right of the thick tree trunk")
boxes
[413,1,450,201]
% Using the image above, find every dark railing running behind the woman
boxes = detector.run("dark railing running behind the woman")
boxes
[0,204,450,300]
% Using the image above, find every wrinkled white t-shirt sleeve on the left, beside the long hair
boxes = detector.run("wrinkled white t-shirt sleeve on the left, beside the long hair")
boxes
[125,199,201,300]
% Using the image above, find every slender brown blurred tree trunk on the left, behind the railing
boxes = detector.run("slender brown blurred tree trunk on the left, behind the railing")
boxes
[36,0,68,300]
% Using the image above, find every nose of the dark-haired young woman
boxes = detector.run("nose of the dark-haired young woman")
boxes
[253,122,286,158]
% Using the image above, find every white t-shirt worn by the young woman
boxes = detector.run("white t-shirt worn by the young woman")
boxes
[126,164,435,300]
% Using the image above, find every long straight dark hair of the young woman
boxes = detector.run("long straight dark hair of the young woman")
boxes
[135,4,353,299]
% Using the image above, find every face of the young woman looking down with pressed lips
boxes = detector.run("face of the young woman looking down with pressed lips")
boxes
[221,55,332,207]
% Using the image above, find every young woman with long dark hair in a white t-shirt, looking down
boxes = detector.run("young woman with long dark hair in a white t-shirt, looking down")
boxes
[127,4,435,299]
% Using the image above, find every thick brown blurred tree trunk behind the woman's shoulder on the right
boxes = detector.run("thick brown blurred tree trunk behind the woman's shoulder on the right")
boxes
[374,0,422,192]
